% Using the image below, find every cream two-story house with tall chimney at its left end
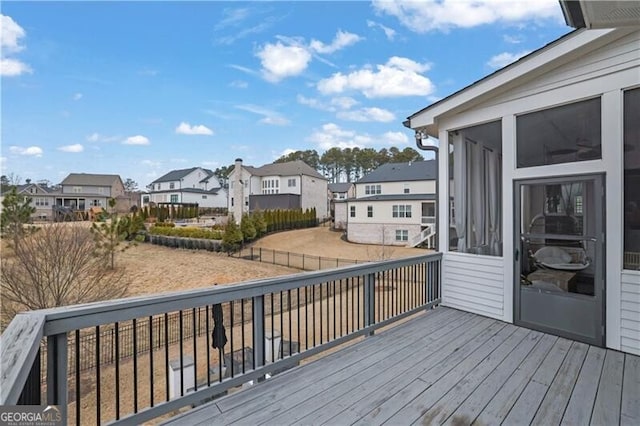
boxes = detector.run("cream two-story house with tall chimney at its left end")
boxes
[228,158,328,221]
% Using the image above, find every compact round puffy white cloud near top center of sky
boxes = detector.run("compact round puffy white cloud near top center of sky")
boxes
[256,41,311,83]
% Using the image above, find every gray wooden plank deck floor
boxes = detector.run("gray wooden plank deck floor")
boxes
[167,307,640,425]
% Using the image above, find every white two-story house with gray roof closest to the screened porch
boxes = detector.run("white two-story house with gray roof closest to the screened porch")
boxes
[347,160,436,247]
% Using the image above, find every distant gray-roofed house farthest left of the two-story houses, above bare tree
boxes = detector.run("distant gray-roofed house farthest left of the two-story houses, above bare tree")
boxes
[55,173,127,211]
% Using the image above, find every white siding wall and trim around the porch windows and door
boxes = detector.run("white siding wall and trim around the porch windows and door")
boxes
[420,30,640,354]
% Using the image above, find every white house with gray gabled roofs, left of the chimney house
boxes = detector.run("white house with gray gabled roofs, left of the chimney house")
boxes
[142,167,227,208]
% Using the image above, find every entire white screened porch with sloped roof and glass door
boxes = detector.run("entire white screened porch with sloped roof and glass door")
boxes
[408,12,640,354]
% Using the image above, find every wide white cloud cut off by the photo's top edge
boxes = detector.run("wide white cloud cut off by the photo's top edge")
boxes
[373,0,562,33]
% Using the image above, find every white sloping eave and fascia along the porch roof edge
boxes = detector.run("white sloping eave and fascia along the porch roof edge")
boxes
[404,29,632,138]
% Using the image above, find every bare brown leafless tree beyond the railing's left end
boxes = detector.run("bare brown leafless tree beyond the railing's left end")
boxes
[0,223,129,321]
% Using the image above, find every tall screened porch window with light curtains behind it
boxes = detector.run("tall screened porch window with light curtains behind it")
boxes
[449,121,502,256]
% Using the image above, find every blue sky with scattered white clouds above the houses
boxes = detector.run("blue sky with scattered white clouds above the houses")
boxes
[0,0,571,188]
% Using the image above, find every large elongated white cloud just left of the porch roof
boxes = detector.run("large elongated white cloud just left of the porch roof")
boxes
[317,56,435,98]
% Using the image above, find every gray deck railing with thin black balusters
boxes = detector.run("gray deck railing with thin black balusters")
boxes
[0,253,441,424]
